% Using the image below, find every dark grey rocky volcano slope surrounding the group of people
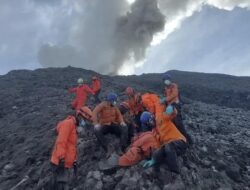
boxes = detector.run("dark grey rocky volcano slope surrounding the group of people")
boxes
[0,67,250,190]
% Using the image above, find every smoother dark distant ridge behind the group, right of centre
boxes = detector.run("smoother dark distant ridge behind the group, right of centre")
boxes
[114,71,250,109]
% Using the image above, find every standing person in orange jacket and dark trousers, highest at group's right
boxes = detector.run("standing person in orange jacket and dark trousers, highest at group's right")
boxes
[161,73,193,145]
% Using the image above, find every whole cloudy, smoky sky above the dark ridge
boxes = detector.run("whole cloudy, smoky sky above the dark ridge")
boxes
[0,0,250,76]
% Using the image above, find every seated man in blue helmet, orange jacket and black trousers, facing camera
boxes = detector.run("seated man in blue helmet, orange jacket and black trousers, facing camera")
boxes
[93,92,127,157]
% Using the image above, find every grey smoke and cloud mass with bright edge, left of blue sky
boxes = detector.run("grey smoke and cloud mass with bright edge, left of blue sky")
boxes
[0,0,250,74]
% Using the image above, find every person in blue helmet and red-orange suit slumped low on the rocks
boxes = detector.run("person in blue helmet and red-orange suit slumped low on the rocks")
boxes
[103,111,160,169]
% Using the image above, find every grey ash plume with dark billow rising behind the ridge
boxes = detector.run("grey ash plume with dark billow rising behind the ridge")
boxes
[38,0,165,74]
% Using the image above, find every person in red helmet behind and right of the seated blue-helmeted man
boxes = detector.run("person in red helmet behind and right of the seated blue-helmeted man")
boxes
[125,87,144,132]
